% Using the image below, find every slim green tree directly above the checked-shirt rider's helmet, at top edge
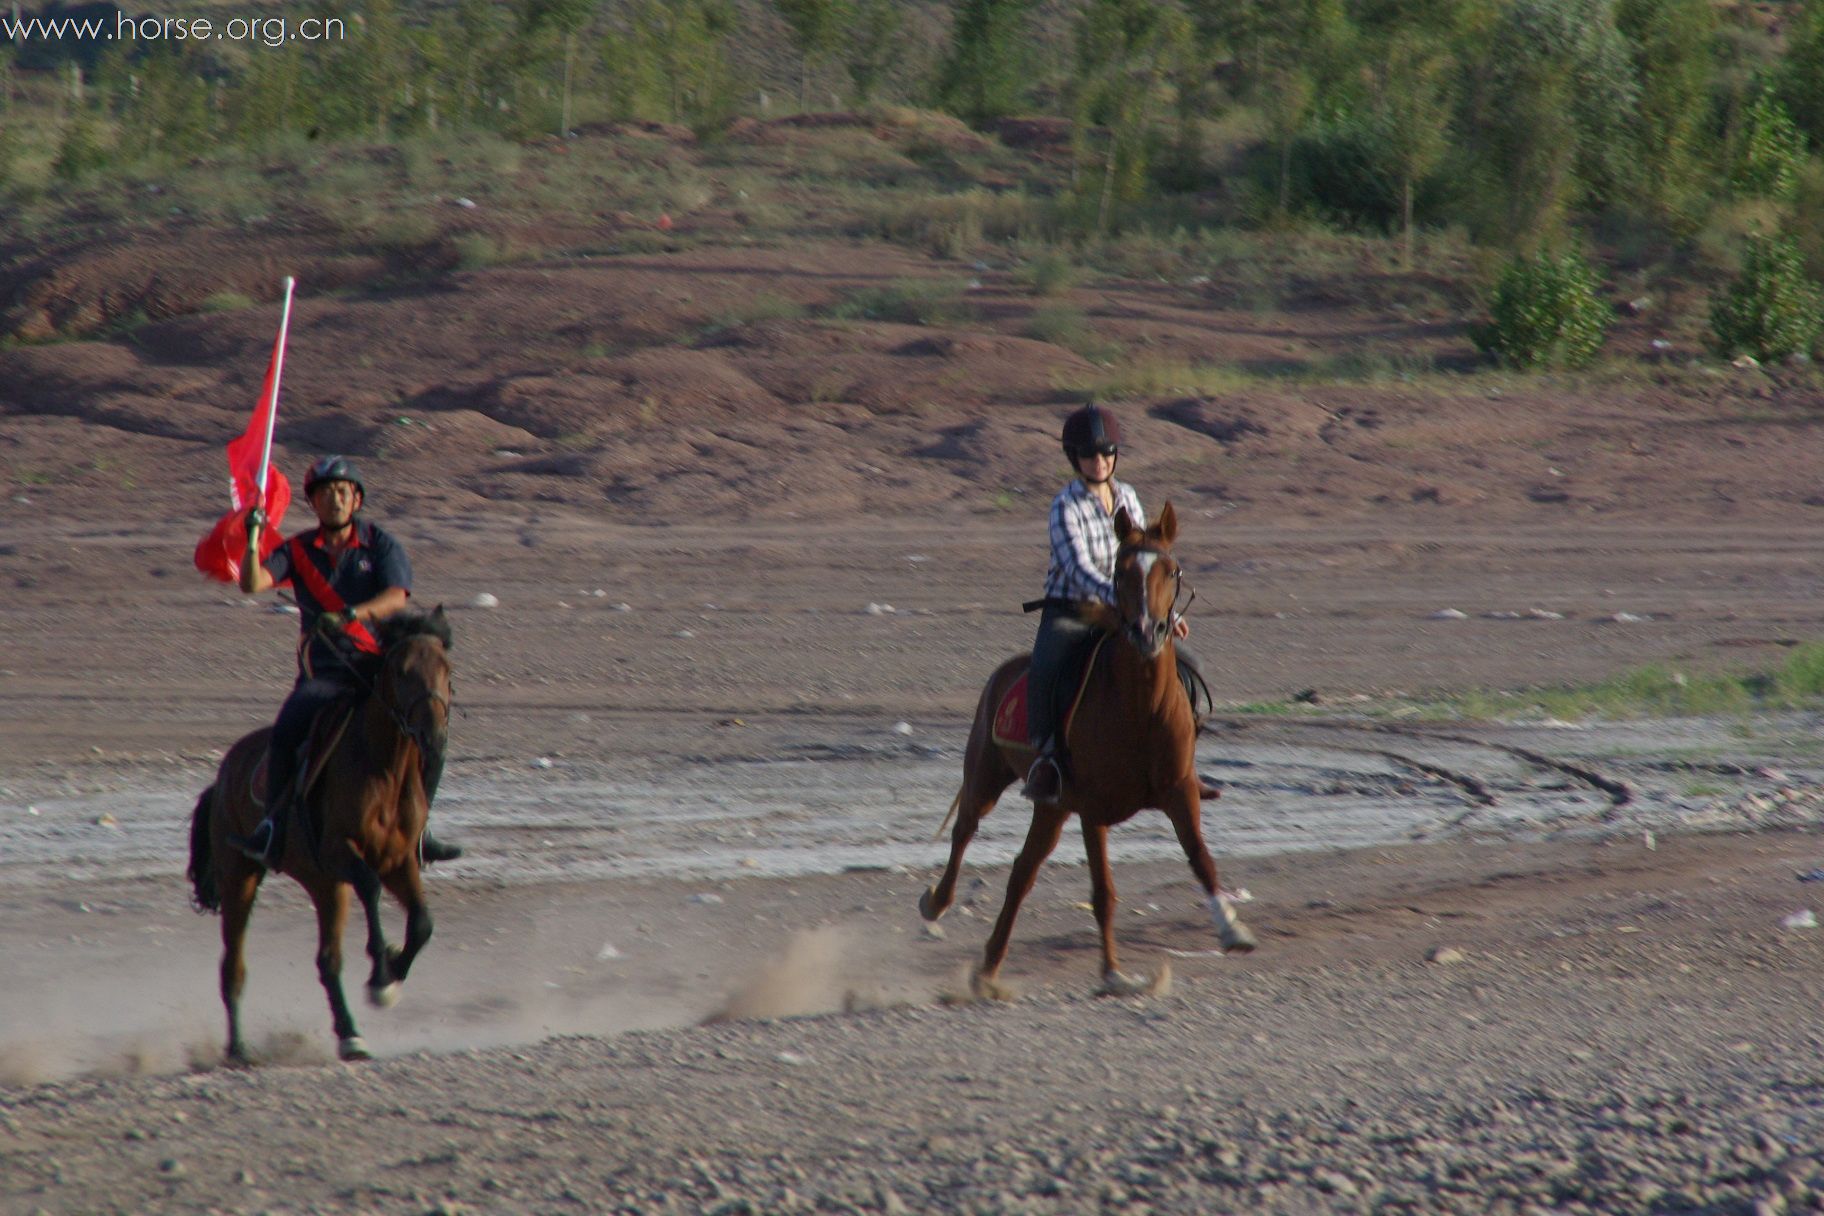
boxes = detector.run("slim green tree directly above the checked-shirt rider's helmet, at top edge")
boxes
[1073,0,1191,232]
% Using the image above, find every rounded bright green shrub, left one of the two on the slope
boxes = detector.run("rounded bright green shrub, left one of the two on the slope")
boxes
[1470,253,1609,368]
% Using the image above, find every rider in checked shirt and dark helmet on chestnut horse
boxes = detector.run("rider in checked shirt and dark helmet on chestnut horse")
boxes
[1020,405,1191,806]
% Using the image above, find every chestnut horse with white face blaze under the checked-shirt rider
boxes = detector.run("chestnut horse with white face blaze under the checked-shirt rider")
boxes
[919,503,1255,999]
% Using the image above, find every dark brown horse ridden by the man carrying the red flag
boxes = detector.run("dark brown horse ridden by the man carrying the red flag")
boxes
[190,607,451,1065]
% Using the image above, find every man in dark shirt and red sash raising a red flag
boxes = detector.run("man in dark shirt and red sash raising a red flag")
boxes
[228,456,461,870]
